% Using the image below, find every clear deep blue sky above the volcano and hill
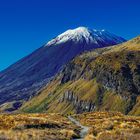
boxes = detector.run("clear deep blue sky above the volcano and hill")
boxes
[0,0,140,70]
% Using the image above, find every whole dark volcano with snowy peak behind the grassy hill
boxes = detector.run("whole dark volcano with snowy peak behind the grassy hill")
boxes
[0,27,125,109]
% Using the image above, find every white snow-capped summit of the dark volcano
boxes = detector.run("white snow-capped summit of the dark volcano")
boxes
[46,27,124,46]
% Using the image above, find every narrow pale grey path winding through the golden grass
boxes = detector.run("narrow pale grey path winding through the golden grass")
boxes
[68,116,89,140]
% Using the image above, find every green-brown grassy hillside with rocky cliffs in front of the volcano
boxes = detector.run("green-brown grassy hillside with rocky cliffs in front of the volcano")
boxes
[20,37,140,115]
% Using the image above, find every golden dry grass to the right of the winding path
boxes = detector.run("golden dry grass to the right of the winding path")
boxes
[75,112,140,140]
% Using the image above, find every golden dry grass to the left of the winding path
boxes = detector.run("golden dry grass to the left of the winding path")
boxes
[0,114,79,140]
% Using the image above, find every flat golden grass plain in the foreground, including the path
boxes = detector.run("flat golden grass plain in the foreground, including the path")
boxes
[0,112,140,140]
